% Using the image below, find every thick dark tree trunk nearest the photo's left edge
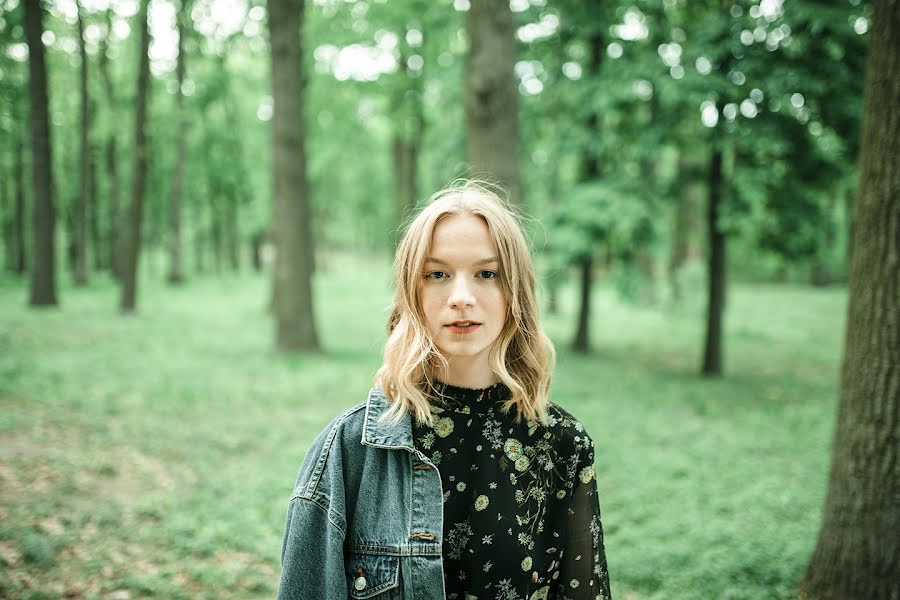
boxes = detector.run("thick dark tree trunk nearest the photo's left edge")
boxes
[25,0,57,306]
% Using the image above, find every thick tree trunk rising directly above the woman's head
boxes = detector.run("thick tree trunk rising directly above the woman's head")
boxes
[465,0,522,204]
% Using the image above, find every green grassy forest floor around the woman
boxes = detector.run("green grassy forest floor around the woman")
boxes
[0,262,845,600]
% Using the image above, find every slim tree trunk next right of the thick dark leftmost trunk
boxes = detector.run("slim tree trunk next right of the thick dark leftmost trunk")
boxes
[72,0,91,285]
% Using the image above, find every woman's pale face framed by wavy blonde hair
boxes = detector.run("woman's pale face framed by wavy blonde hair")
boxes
[419,214,506,386]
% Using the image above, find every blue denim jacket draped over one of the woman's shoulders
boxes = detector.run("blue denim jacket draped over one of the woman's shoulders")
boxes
[278,388,444,600]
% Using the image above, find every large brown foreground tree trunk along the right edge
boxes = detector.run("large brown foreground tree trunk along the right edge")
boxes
[800,0,900,600]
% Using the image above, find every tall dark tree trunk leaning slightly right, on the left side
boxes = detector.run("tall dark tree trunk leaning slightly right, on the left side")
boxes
[119,0,150,313]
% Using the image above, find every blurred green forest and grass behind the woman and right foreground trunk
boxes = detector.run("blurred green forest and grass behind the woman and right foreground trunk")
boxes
[0,0,884,600]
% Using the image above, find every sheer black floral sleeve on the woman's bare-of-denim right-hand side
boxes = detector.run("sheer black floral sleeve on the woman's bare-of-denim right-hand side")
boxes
[557,442,612,600]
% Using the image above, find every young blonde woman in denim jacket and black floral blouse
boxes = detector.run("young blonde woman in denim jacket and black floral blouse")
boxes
[278,183,610,600]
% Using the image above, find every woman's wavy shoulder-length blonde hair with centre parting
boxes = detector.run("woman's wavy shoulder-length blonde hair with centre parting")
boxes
[375,180,556,425]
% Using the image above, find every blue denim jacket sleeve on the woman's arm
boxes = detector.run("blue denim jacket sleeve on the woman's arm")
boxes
[278,408,366,600]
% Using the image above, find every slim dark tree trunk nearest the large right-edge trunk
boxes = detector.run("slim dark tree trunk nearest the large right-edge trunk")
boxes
[702,148,725,376]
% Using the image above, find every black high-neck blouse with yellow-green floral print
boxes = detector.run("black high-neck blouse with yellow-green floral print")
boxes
[413,383,611,600]
